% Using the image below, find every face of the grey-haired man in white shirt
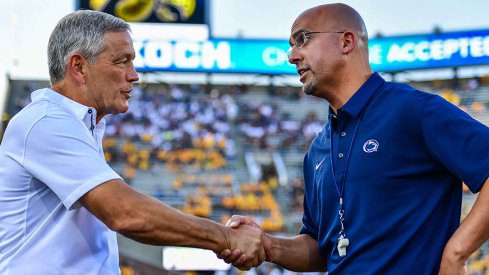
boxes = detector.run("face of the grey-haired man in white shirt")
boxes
[86,31,139,117]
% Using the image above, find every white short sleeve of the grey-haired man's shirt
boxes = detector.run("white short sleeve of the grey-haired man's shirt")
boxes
[22,113,120,209]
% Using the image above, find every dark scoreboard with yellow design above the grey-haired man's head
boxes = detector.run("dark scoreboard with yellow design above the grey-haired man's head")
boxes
[77,0,209,24]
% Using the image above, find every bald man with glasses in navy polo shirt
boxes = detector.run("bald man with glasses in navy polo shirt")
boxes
[219,4,489,275]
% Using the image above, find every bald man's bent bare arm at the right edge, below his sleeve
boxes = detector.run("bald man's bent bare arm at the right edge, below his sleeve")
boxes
[443,179,489,263]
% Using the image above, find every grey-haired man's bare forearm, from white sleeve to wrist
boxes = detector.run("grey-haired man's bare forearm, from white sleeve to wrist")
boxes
[82,181,232,251]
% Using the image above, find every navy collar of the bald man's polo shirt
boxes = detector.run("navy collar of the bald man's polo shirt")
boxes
[329,73,385,117]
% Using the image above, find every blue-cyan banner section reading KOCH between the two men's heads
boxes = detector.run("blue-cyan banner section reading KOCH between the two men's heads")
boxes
[134,39,296,74]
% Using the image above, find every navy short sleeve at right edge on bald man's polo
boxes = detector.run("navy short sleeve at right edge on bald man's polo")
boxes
[421,96,489,193]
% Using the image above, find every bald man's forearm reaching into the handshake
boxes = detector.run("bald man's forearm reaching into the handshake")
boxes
[267,234,327,272]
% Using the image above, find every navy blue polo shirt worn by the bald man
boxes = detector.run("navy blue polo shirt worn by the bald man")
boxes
[301,73,489,275]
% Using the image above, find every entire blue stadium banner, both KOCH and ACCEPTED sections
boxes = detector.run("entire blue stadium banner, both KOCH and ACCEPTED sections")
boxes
[134,30,489,75]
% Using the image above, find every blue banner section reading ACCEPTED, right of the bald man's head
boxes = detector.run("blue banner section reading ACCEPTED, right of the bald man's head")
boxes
[369,30,489,72]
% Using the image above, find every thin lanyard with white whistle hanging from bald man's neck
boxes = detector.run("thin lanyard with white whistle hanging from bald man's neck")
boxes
[329,111,363,257]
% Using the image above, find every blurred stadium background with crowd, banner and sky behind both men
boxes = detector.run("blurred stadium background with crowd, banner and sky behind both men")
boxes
[0,0,489,275]
